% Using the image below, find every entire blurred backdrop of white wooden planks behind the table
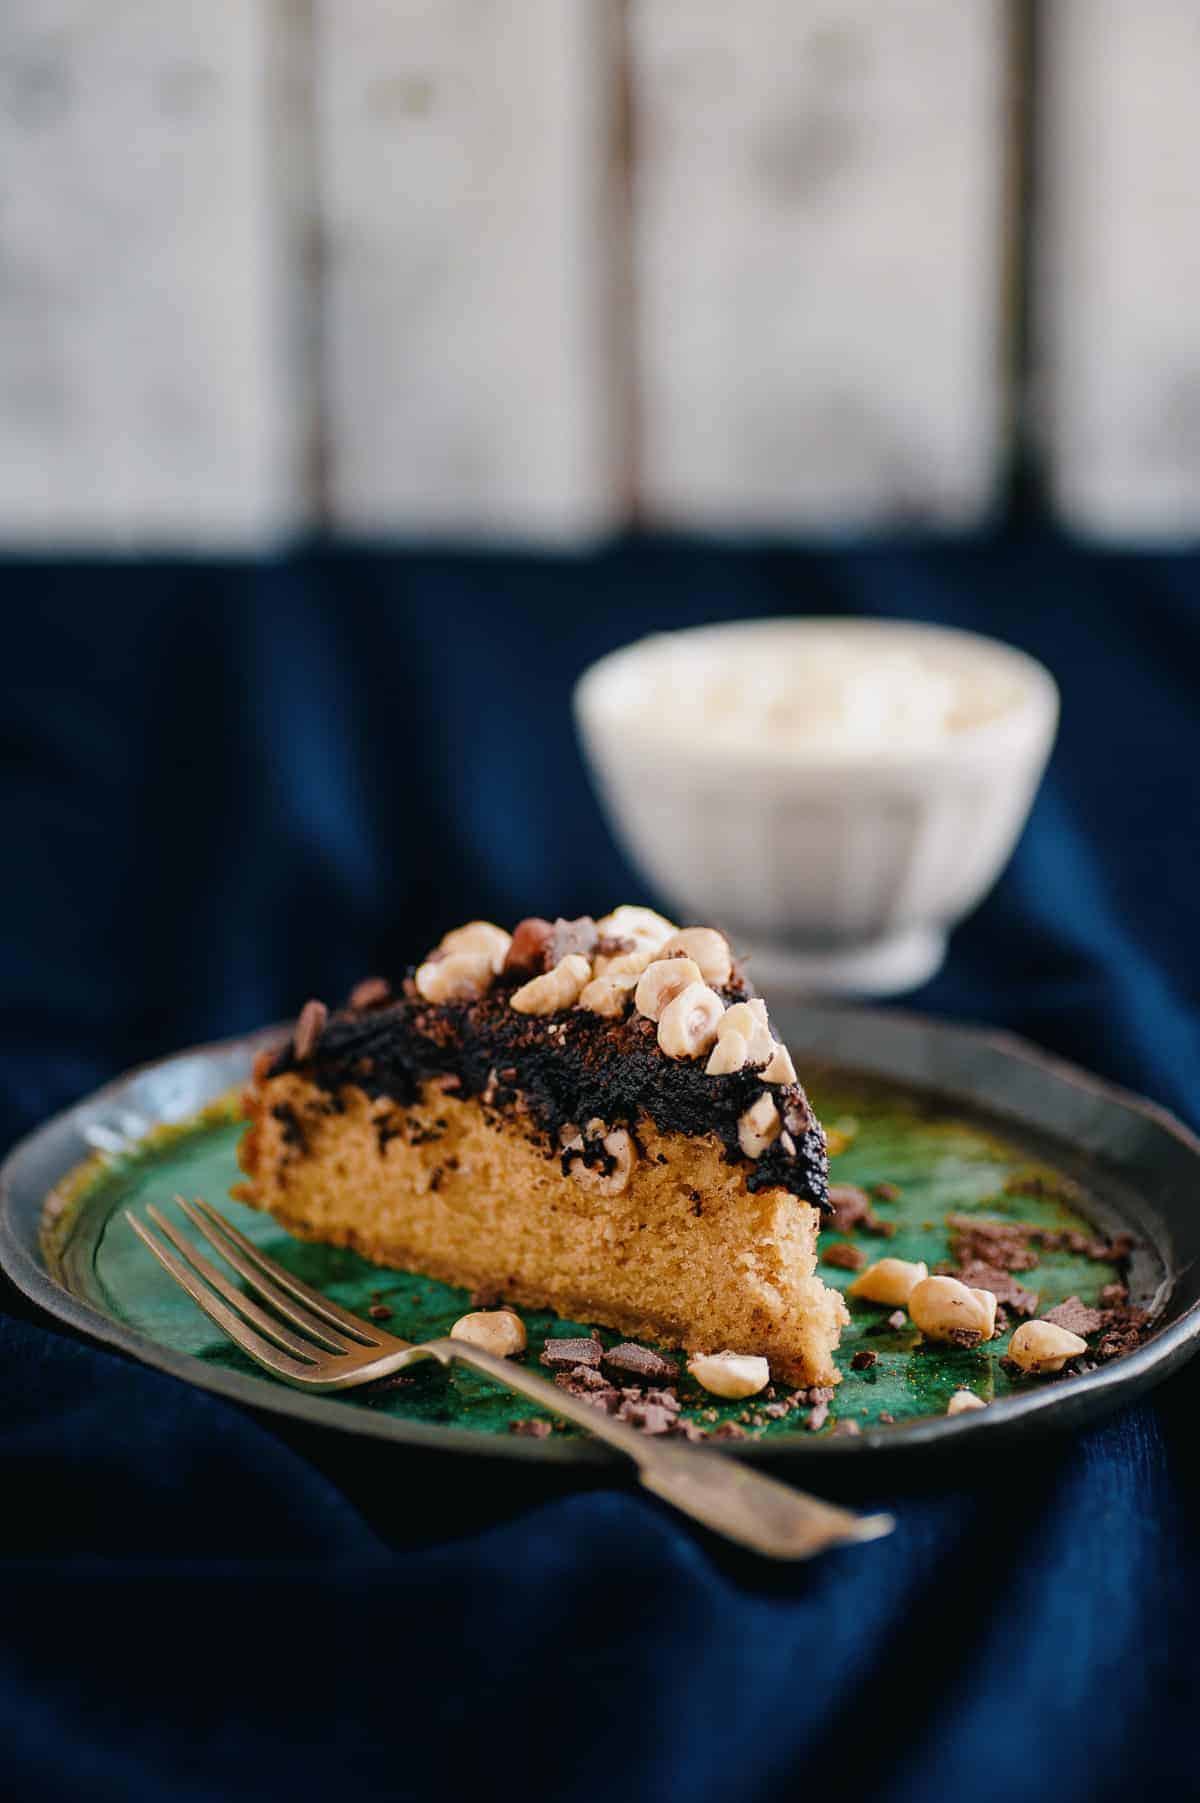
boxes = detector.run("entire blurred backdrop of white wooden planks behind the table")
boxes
[0,0,1200,552]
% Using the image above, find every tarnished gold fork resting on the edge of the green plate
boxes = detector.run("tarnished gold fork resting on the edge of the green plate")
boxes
[126,1195,895,1560]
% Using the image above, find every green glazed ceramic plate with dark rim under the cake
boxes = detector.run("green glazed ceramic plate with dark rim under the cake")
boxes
[0,1008,1200,1459]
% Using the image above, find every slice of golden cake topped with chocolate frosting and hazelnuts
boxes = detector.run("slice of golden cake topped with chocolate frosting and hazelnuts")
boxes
[234,907,847,1385]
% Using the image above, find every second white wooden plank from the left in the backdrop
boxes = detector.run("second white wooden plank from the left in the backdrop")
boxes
[317,0,623,539]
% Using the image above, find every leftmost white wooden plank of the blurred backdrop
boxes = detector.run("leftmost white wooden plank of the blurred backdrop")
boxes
[0,0,303,550]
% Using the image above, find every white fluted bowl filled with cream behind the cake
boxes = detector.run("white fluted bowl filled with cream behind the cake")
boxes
[575,618,1058,993]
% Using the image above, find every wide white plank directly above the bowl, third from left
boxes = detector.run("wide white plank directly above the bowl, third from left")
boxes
[631,0,1007,534]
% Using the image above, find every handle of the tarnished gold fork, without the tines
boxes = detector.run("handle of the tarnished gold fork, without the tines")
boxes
[405,1340,895,1560]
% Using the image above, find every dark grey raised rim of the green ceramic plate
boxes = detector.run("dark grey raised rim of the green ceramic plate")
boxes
[0,1002,1200,1468]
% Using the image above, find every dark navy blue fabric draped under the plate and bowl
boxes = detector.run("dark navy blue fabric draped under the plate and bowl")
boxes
[0,530,1200,1803]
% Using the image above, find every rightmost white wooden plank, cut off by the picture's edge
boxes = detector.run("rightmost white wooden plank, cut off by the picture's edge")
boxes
[1036,0,1200,541]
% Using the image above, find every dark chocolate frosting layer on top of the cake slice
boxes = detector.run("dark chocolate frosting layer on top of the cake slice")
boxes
[270,972,829,1210]
